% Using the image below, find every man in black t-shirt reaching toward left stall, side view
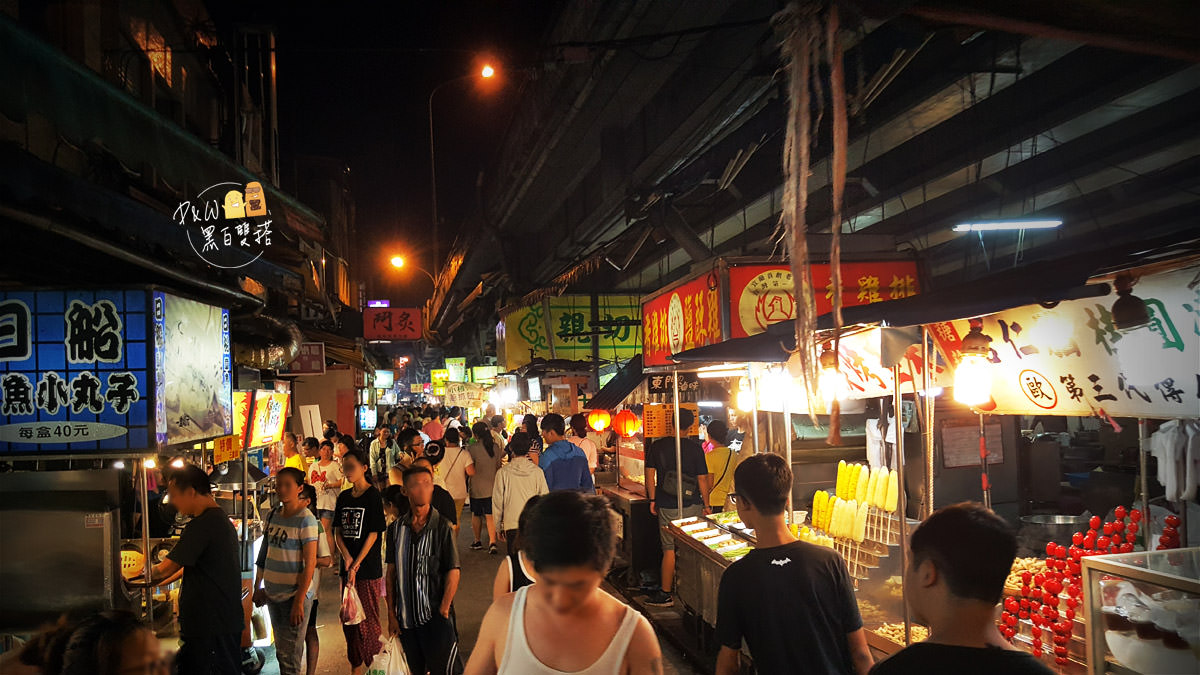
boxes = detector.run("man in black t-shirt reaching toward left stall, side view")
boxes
[141,465,245,675]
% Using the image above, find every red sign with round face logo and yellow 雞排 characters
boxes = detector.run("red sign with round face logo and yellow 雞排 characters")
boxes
[730,261,920,338]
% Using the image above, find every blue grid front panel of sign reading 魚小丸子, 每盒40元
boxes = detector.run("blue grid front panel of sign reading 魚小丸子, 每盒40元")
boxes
[0,291,154,453]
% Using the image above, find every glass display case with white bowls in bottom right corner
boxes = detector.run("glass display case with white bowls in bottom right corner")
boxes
[1082,548,1200,674]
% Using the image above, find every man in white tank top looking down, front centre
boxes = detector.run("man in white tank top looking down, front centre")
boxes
[466,491,662,675]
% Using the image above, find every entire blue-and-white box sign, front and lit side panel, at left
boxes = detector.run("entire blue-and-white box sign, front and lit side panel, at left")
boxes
[0,288,232,455]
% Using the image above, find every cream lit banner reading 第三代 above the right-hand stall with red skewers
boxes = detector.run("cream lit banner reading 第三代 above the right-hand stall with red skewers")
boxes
[930,267,1200,419]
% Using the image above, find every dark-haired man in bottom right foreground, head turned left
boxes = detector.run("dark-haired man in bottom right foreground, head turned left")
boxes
[871,502,1052,675]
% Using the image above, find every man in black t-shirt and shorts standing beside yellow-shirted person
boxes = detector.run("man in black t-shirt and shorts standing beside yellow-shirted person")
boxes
[646,408,713,607]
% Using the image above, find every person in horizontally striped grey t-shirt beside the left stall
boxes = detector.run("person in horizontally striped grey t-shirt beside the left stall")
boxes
[254,467,318,675]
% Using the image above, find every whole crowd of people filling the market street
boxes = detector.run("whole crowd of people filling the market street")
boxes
[0,398,1049,675]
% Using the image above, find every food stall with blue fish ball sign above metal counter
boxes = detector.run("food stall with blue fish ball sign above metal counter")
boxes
[0,287,233,632]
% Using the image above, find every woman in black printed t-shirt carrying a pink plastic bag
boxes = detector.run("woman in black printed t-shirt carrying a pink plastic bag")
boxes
[334,448,385,673]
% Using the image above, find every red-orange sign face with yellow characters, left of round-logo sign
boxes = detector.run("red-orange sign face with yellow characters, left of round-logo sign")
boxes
[642,273,722,365]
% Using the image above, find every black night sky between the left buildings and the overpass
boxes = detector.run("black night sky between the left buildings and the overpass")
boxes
[235,0,560,304]
